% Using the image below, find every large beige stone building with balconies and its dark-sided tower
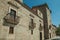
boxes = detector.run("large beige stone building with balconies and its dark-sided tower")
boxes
[0,0,56,40]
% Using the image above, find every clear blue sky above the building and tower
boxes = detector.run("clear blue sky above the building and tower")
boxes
[23,0,60,26]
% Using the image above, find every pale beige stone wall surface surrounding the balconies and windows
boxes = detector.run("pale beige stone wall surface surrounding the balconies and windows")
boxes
[0,0,44,40]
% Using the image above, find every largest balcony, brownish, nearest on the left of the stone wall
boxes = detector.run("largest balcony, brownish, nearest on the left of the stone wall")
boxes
[4,14,19,25]
